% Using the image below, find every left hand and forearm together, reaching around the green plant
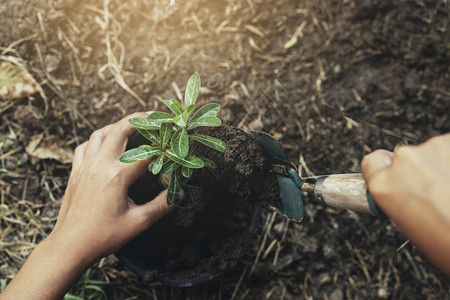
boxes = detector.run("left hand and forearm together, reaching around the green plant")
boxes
[2,113,176,299]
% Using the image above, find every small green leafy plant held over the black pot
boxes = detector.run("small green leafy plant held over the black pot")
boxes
[119,72,226,205]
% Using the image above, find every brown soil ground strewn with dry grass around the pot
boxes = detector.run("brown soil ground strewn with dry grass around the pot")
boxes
[0,0,450,300]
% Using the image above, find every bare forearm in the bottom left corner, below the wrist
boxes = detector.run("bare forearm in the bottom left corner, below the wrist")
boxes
[0,235,94,299]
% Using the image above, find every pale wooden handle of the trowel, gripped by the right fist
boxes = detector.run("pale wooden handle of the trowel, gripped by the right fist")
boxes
[314,173,382,216]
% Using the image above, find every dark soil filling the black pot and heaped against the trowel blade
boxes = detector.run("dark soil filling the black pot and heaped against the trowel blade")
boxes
[119,126,278,283]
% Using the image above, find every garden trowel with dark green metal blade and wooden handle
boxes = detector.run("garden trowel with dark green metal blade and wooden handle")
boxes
[252,131,382,222]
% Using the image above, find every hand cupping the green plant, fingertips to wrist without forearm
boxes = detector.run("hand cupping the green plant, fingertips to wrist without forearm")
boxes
[50,113,171,260]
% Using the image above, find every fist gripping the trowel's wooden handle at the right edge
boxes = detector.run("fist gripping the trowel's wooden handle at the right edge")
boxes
[361,134,450,275]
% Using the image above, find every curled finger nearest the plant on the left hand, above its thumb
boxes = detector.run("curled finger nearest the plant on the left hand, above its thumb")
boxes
[100,112,147,160]
